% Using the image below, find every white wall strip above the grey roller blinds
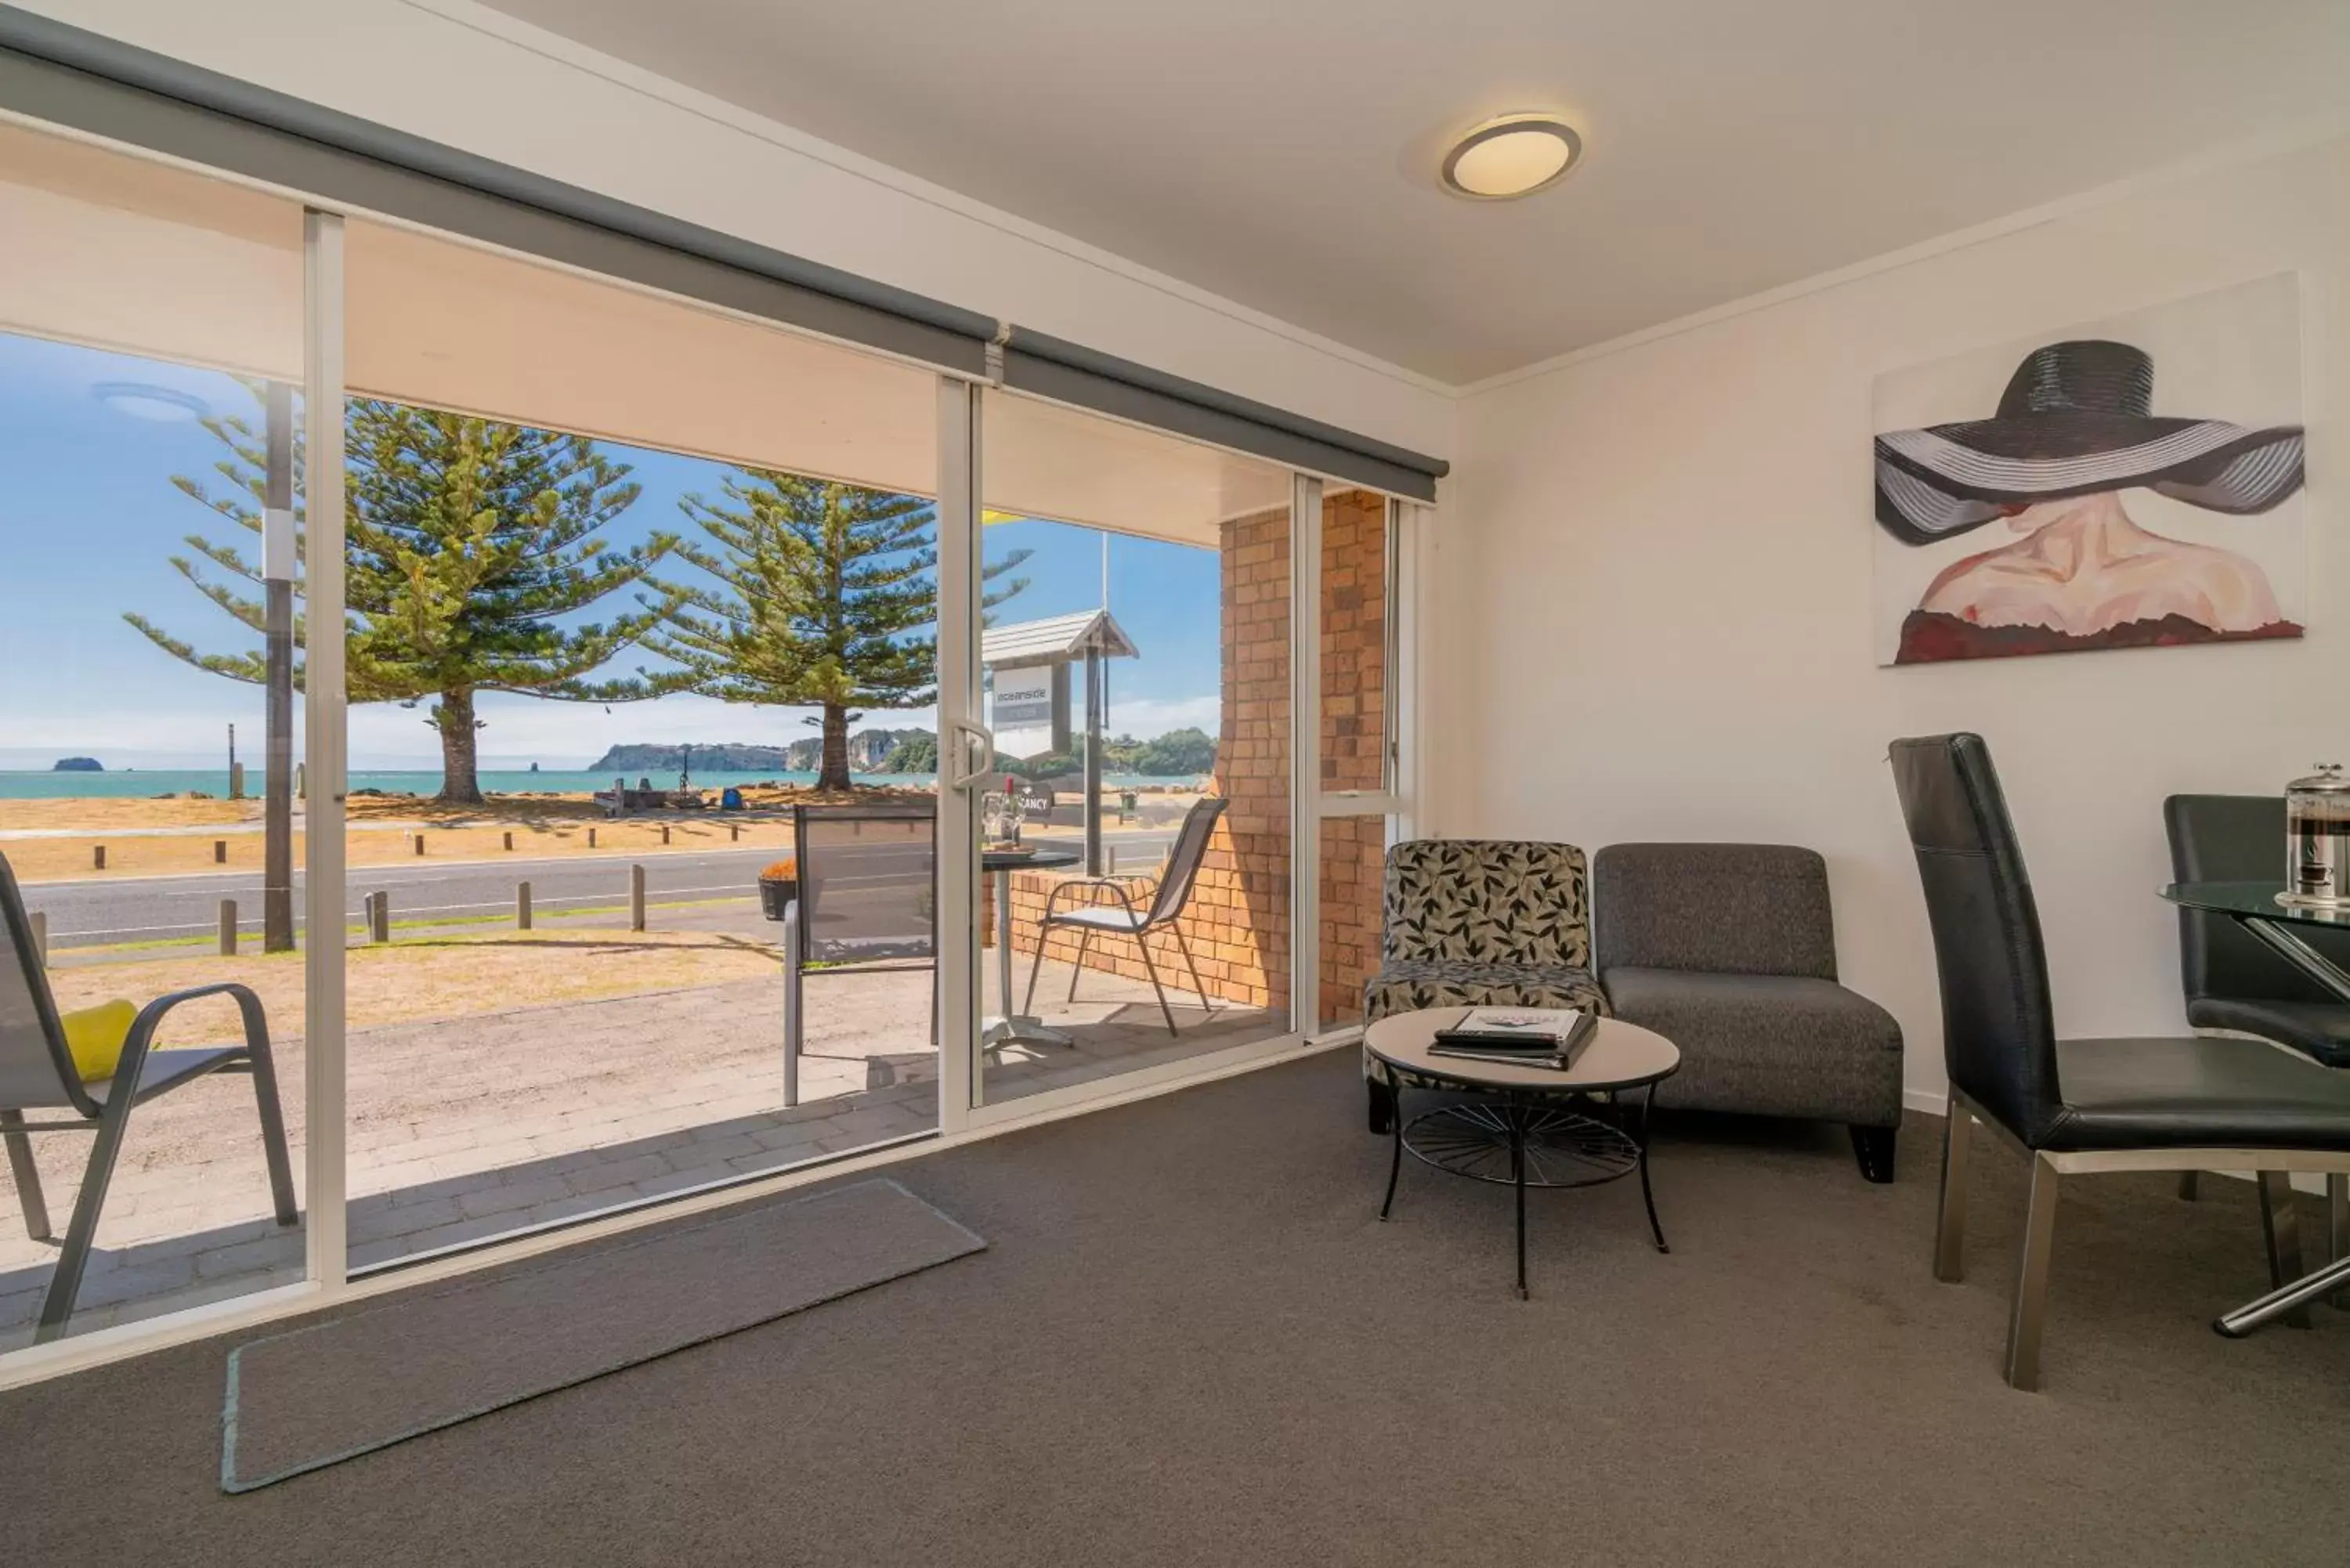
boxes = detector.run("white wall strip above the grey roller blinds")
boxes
[21,0,1452,456]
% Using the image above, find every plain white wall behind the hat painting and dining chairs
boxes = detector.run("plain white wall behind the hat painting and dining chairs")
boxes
[1443,141,2350,1100]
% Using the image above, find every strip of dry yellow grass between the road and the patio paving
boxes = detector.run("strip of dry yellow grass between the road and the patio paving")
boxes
[49,929,778,1046]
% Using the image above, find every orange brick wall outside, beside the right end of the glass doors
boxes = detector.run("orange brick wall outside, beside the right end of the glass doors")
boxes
[1013,493,1386,1021]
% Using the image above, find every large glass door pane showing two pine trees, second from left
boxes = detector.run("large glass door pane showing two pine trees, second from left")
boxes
[331,221,938,1270]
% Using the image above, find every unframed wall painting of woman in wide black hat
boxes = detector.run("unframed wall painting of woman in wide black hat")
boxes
[1875,280,2303,665]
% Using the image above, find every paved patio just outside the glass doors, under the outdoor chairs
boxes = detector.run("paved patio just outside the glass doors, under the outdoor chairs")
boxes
[0,910,1271,1349]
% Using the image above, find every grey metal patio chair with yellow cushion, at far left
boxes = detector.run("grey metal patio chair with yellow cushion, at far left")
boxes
[0,856,301,1342]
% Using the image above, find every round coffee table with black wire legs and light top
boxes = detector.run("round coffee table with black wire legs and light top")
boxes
[1363,1006,1680,1300]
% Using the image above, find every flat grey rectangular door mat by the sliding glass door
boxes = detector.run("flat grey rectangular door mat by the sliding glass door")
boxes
[221,1180,987,1493]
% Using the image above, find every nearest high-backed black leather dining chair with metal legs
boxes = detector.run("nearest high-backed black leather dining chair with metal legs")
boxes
[1892,733,2350,1389]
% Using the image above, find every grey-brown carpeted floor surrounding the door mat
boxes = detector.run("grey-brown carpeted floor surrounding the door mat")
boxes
[0,1051,2350,1568]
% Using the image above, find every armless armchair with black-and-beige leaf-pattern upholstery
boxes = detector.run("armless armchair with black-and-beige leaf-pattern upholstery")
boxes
[1363,840,1607,1133]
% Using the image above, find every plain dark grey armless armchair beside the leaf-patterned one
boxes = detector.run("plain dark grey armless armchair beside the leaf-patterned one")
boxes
[1593,844,1901,1183]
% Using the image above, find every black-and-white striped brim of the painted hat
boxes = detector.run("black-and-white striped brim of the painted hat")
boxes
[1878,414,2303,545]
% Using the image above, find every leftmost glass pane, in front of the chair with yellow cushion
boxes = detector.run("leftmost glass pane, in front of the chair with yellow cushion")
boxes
[0,127,306,1347]
